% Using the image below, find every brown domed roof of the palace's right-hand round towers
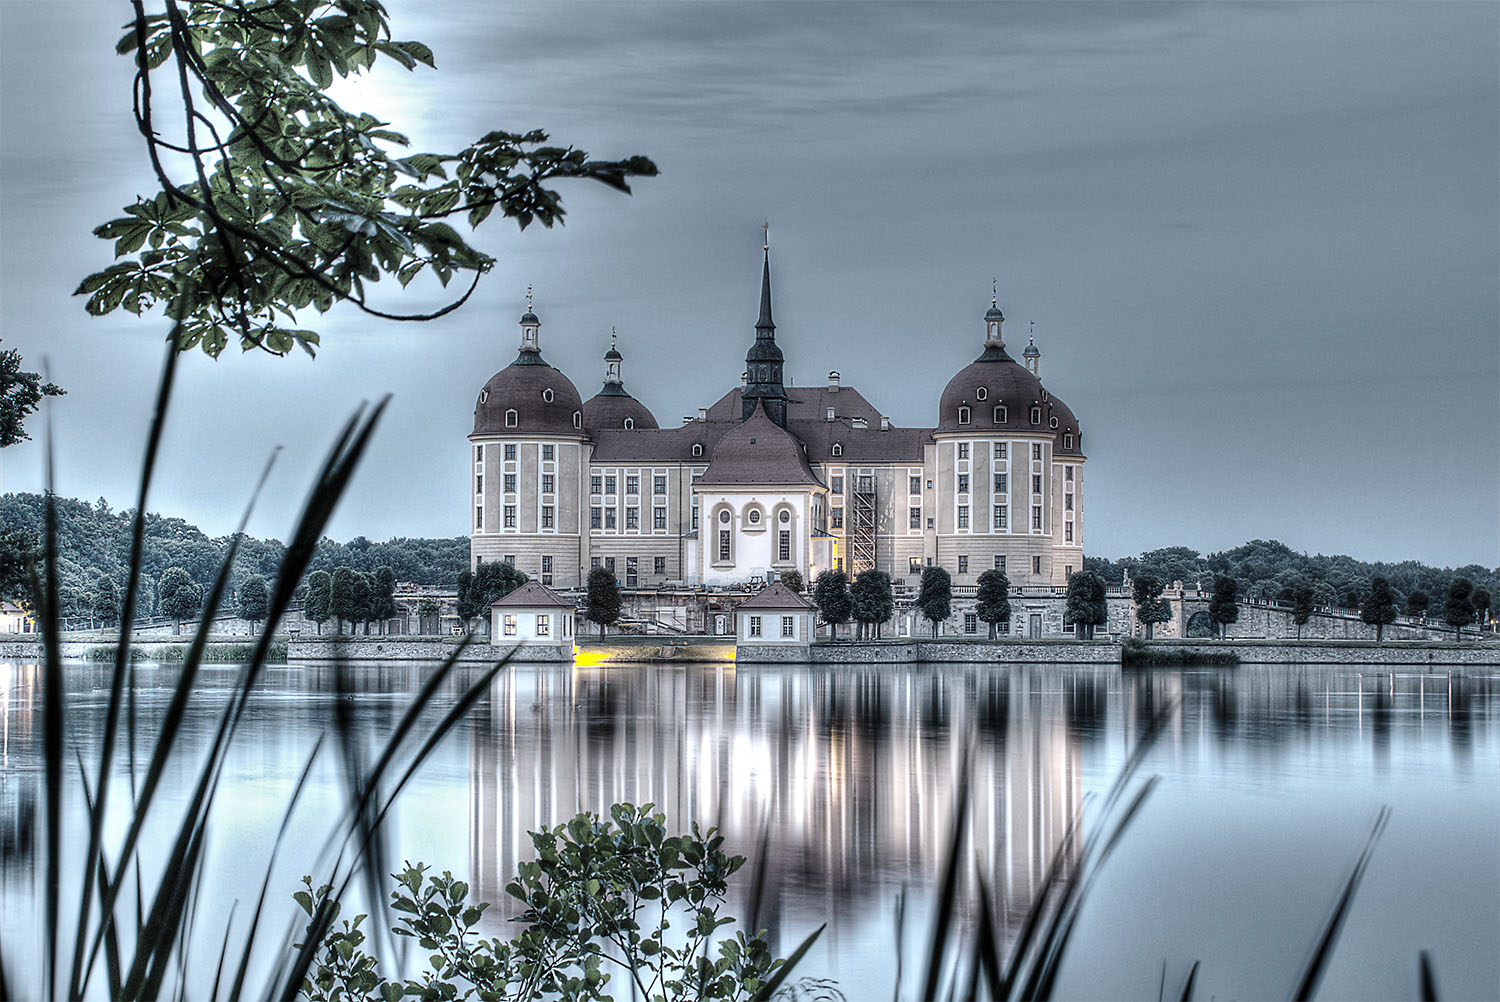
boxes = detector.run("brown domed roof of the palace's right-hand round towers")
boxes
[938,347,1079,453]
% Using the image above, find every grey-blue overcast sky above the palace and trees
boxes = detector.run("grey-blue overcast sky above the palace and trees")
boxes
[0,0,1500,567]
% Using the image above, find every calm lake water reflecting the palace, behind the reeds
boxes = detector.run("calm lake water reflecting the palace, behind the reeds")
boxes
[0,662,1500,999]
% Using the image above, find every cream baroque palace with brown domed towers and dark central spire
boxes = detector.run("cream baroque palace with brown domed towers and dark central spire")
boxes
[470,248,1085,594]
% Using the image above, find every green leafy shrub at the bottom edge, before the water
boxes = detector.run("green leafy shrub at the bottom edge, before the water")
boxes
[294,804,822,1002]
